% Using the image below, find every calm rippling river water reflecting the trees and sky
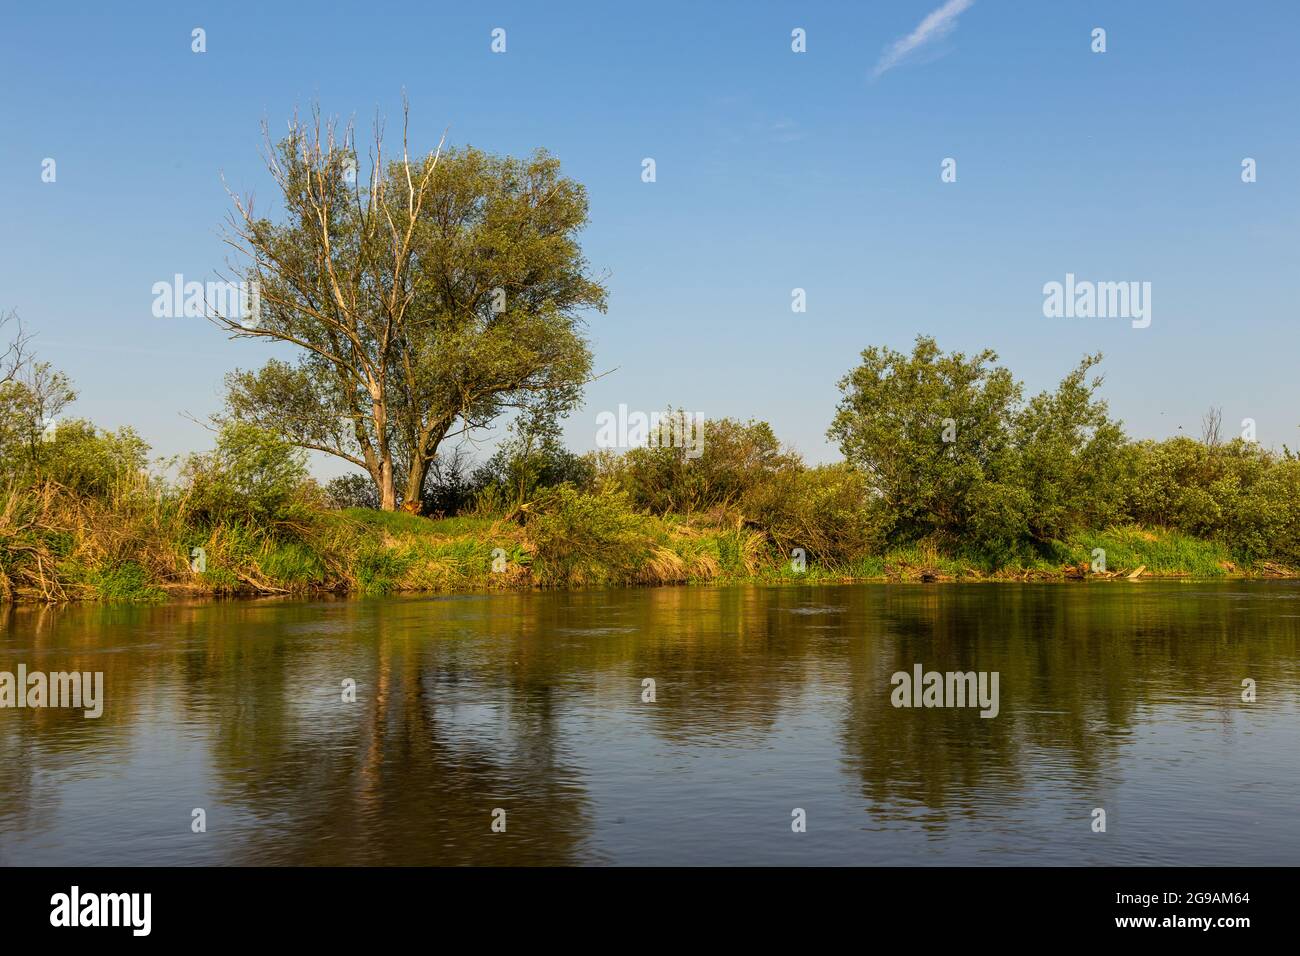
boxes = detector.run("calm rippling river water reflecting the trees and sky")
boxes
[0,581,1300,865]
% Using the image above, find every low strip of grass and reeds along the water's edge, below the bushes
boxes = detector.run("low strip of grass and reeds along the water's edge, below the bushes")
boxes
[0,486,1296,604]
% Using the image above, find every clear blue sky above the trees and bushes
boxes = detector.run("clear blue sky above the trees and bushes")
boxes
[0,0,1300,475]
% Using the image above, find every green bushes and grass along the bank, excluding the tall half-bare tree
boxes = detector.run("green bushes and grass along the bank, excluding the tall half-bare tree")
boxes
[0,317,1300,601]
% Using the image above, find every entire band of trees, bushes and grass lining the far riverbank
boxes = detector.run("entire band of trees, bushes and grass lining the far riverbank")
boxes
[0,109,1300,604]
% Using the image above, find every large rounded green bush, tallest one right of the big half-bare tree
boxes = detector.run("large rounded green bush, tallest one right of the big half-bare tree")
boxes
[829,337,1126,561]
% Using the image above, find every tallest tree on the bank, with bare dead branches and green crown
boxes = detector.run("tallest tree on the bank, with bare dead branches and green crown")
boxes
[215,104,606,510]
